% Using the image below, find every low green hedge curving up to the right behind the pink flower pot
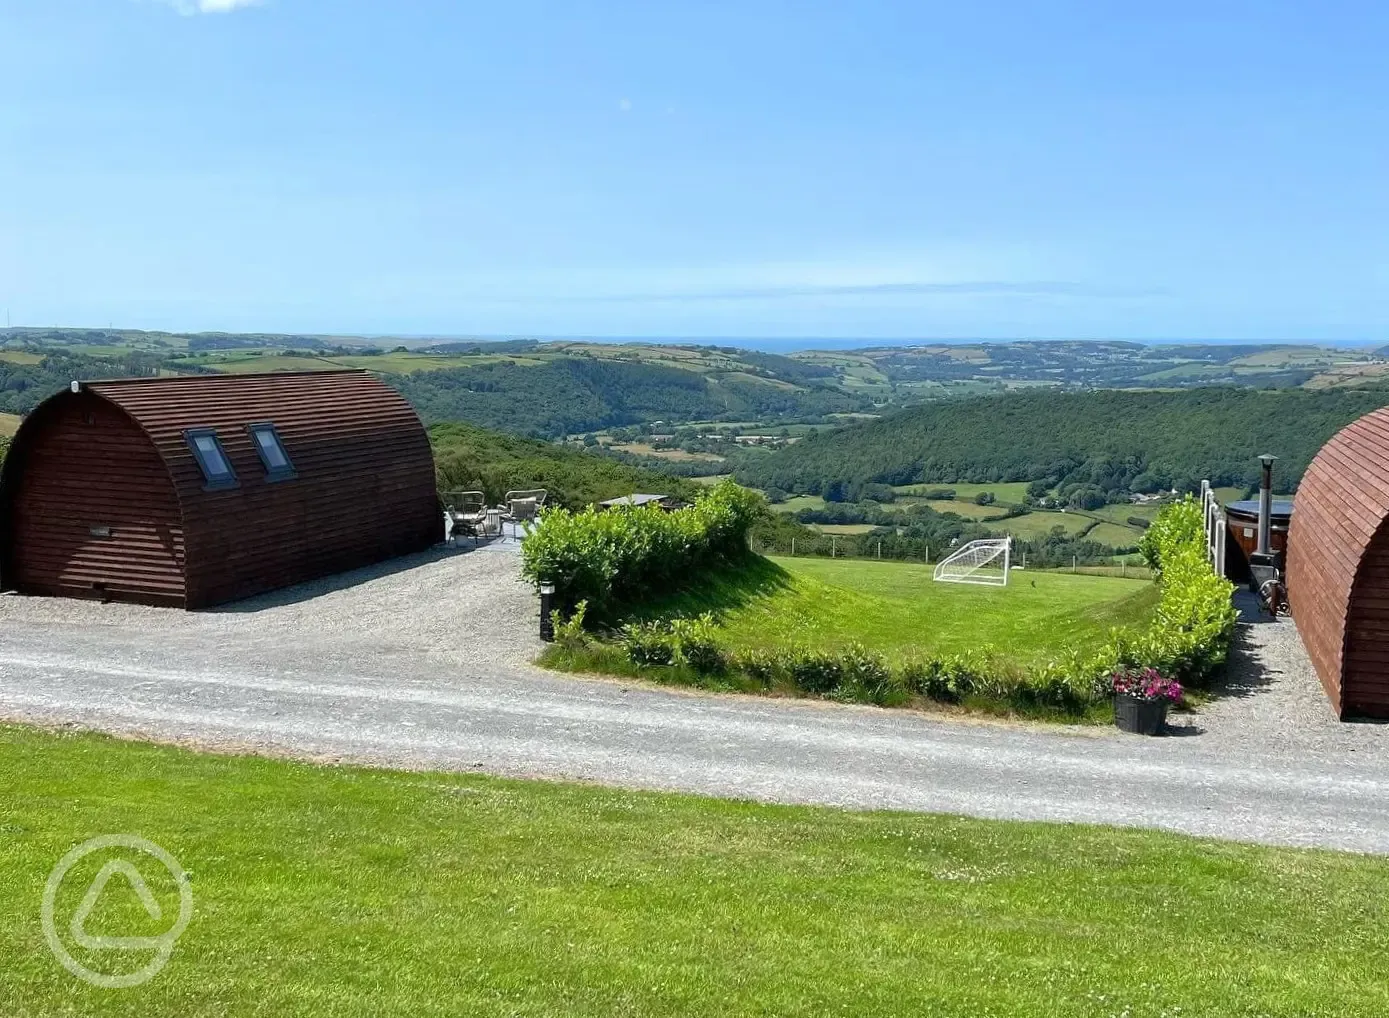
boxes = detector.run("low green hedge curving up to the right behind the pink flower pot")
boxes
[547,500,1236,717]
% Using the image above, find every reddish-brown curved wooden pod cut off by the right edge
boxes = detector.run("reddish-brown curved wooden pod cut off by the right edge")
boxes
[1288,408,1389,718]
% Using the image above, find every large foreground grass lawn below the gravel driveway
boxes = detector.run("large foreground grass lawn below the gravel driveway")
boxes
[0,728,1389,1018]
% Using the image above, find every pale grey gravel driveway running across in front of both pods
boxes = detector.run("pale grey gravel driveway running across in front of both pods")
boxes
[0,542,1389,851]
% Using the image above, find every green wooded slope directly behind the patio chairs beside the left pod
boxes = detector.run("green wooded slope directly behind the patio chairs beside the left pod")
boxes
[429,424,700,508]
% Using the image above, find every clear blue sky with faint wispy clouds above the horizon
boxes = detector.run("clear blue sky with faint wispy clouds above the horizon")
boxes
[0,0,1389,342]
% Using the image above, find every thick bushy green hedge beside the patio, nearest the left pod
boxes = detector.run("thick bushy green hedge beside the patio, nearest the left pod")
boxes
[521,481,767,619]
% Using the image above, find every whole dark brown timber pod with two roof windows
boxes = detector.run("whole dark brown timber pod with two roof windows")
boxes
[0,371,443,608]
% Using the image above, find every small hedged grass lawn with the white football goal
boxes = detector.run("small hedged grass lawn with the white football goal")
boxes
[642,558,1157,662]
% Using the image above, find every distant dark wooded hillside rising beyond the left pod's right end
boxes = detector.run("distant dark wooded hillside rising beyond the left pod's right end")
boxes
[385,357,861,437]
